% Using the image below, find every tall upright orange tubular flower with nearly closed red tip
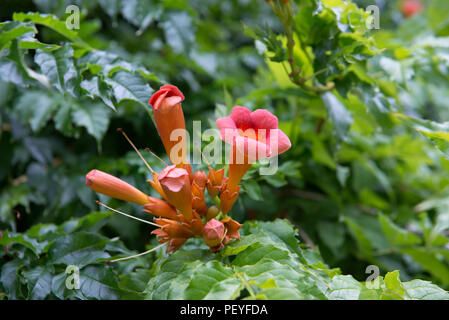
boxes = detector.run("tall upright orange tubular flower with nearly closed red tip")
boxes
[148,85,187,166]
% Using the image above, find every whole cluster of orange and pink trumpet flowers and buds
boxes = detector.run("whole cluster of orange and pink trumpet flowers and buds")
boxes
[86,85,290,252]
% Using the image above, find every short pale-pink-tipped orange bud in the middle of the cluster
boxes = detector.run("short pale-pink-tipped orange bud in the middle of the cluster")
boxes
[158,165,193,221]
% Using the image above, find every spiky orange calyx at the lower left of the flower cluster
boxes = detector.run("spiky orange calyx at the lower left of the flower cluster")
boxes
[151,218,194,253]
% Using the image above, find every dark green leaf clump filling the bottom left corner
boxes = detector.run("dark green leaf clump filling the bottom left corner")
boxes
[0,212,136,299]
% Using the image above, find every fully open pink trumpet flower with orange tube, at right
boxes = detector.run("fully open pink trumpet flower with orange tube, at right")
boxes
[216,106,291,190]
